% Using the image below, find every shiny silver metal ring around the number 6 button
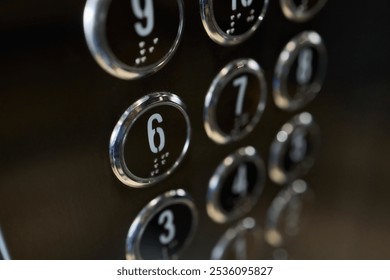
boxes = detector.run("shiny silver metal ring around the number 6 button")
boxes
[109,92,191,188]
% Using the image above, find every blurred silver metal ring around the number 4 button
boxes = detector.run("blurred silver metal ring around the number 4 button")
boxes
[206,146,266,224]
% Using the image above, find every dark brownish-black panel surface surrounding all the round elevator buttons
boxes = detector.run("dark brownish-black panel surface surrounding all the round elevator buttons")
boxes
[0,0,390,259]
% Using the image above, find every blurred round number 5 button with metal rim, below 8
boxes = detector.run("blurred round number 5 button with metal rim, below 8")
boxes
[269,113,320,184]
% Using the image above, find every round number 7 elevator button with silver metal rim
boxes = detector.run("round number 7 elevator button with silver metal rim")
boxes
[203,59,267,144]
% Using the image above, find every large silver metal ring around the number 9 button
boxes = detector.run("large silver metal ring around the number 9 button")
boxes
[83,0,184,80]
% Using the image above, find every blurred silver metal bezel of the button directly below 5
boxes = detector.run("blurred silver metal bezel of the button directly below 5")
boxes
[264,180,309,248]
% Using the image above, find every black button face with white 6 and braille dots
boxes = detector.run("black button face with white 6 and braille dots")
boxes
[124,104,188,178]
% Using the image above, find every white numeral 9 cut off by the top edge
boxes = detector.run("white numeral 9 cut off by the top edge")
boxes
[131,0,154,37]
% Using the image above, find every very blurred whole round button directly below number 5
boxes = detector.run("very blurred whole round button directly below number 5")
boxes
[265,180,309,247]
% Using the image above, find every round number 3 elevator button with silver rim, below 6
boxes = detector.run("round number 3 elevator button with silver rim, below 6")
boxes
[126,189,198,260]
